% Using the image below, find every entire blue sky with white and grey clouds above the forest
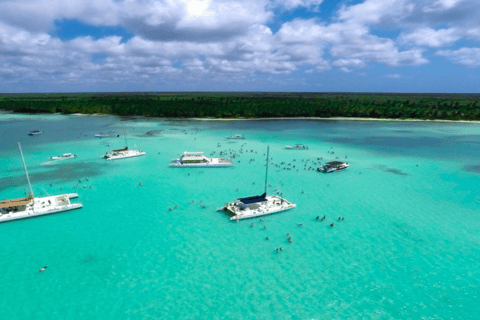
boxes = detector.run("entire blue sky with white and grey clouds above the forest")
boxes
[0,0,480,93]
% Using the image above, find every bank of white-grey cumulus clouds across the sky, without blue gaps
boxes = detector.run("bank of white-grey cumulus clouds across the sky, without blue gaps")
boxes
[0,0,480,89]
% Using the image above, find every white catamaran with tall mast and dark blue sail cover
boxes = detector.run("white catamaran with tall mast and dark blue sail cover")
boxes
[217,148,297,221]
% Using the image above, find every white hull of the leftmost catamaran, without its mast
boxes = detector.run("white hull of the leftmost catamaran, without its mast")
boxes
[0,193,83,223]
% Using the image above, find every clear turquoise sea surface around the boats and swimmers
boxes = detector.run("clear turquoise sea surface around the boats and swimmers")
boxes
[0,115,480,319]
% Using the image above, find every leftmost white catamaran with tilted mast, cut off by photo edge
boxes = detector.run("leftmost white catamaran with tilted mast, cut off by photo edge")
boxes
[0,143,83,223]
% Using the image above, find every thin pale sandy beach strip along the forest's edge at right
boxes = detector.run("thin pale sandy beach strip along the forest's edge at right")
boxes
[185,117,480,124]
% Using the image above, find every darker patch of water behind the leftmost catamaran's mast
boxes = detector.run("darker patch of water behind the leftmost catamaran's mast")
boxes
[0,162,105,191]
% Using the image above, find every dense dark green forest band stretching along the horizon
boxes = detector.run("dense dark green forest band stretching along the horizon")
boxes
[0,92,480,120]
